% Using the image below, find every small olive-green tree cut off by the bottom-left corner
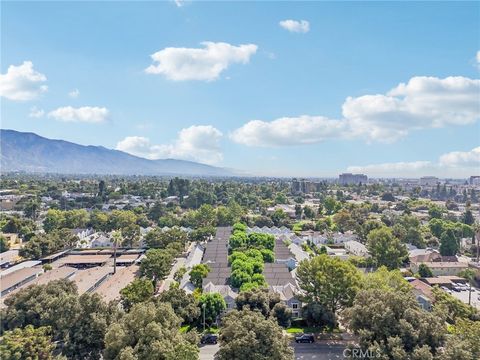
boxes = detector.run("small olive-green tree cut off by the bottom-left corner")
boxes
[0,325,55,360]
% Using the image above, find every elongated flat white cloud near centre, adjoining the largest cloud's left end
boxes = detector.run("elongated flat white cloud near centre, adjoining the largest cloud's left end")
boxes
[230,115,345,147]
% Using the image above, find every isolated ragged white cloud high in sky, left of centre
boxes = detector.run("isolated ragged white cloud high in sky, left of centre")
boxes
[145,41,258,81]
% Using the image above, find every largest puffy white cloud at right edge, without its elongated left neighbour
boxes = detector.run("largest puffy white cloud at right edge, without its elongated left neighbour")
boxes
[342,76,480,142]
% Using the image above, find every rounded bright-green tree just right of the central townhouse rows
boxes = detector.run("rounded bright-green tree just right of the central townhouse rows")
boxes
[297,254,361,313]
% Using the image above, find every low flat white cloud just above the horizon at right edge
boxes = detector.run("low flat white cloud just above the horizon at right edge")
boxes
[347,146,480,177]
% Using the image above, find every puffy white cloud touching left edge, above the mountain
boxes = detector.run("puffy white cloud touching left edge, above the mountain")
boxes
[0,61,48,101]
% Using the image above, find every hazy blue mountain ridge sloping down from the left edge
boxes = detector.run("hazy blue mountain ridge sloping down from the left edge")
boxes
[0,129,233,176]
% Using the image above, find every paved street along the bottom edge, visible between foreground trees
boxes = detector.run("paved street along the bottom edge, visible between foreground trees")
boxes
[200,342,345,360]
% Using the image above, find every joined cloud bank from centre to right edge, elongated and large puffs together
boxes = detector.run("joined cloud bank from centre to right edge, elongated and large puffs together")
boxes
[232,76,480,146]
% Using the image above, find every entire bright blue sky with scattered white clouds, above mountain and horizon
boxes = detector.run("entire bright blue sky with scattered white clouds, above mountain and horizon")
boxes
[0,1,480,177]
